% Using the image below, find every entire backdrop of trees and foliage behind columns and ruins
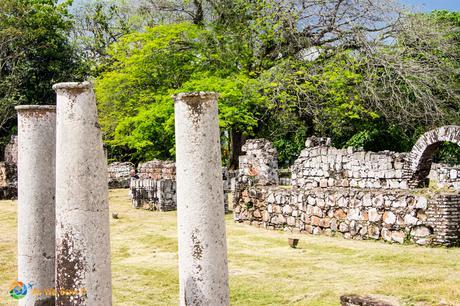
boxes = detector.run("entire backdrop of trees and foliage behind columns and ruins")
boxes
[0,0,460,166]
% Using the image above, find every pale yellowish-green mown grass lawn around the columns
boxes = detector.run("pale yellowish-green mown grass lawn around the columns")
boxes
[0,190,460,305]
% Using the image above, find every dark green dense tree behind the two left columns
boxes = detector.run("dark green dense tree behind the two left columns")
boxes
[0,0,78,151]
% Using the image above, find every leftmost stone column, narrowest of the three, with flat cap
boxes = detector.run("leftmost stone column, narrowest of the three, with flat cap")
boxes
[16,105,56,305]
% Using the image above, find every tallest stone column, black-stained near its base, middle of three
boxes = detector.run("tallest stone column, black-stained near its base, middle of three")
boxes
[53,82,112,306]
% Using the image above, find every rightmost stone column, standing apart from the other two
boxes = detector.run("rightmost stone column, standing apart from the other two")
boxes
[174,92,229,305]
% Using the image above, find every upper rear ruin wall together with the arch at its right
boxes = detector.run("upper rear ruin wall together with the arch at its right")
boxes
[291,126,460,191]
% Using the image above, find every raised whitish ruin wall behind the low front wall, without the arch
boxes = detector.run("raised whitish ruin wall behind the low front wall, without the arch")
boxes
[291,137,410,189]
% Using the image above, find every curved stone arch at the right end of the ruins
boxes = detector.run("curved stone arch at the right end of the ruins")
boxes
[407,125,460,187]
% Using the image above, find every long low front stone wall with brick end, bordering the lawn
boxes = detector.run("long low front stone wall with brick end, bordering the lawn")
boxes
[233,186,460,245]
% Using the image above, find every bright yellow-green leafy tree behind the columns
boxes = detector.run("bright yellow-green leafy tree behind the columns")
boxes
[96,23,264,165]
